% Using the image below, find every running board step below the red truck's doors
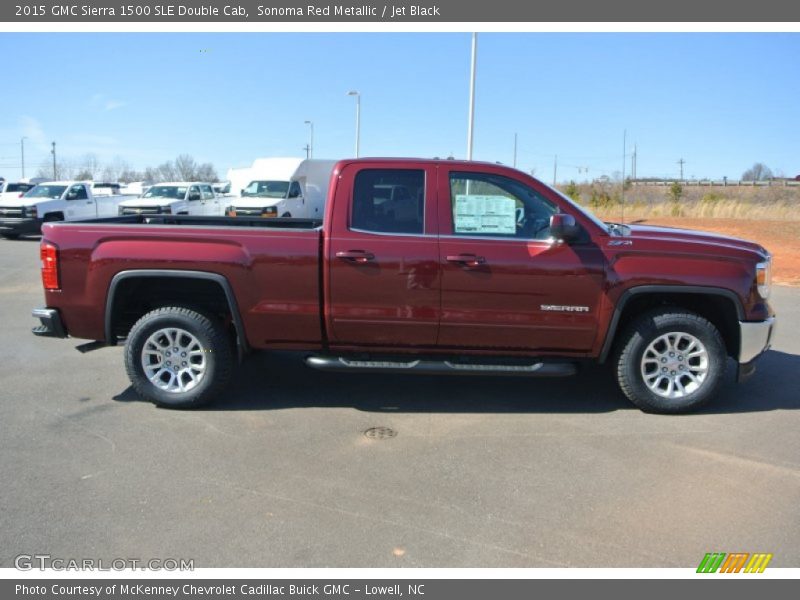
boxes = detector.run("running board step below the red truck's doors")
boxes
[306,356,577,377]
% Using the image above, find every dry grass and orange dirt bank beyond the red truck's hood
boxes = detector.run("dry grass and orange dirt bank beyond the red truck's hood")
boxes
[562,185,800,286]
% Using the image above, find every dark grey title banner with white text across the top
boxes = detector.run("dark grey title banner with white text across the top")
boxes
[0,0,800,23]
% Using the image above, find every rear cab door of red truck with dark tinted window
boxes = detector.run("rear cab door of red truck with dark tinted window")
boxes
[325,161,439,347]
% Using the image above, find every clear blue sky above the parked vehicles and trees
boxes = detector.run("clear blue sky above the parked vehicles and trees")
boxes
[0,33,800,181]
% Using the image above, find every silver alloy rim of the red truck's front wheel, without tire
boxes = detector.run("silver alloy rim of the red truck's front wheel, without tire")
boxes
[641,331,708,399]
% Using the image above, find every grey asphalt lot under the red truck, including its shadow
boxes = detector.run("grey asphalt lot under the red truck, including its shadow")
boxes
[0,240,800,567]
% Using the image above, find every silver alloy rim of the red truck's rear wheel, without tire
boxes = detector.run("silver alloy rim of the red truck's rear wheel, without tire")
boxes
[142,327,208,394]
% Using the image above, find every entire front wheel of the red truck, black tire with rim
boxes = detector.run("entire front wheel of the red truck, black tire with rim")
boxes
[616,309,728,414]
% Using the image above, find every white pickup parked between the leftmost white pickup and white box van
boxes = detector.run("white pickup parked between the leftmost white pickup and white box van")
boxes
[119,181,223,217]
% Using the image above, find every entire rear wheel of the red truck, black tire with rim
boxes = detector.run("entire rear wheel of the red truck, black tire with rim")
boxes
[125,306,234,408]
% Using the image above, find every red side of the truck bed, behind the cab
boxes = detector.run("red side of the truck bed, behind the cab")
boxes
[42,215,322,348]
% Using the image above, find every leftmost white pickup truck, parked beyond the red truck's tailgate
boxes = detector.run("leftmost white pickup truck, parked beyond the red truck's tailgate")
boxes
[0,181,129,239]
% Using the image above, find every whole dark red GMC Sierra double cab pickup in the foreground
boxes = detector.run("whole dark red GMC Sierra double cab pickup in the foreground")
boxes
[33,159,775,413]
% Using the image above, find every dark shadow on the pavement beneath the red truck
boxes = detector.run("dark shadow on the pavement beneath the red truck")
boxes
[114,351,800,414]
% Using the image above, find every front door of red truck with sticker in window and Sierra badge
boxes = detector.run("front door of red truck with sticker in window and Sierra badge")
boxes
[438,165,604,352]
